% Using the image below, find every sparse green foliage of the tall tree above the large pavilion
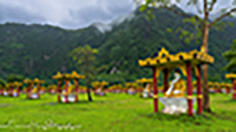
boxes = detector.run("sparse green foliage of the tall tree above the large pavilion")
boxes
[138,0,236,47]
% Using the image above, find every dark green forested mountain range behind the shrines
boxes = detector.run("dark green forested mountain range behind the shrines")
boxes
[0,9,236,81]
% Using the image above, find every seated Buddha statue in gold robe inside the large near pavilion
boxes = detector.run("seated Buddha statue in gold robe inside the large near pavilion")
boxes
[165,70,186,98]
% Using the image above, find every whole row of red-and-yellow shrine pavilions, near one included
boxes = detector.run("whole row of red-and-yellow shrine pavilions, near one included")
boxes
[0,48,236,116]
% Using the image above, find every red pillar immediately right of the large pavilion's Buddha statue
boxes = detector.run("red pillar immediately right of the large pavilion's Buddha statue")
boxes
[187,63,193,116]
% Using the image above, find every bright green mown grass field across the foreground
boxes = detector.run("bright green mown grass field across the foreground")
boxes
[0,94,236,132]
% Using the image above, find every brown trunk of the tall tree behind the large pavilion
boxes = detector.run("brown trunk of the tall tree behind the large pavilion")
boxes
[203,24,211,112]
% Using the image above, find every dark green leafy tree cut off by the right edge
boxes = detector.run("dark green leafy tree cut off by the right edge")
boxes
[223,39,236,73]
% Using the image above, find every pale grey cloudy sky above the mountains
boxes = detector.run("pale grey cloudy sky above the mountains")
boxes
[0,0,233,29]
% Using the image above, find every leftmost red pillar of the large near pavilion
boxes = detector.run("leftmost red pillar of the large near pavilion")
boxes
[153,67,158,113]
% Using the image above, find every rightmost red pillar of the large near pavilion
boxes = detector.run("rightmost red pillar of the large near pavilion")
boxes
[197,65,203,114]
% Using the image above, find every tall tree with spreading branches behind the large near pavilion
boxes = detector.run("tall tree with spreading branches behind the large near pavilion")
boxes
[138,0,236,112]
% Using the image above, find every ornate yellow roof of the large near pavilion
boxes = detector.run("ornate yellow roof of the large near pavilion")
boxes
[139,47,214,68]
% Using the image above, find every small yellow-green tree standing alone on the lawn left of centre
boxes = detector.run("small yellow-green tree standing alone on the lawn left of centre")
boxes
[70,45,98,101]
